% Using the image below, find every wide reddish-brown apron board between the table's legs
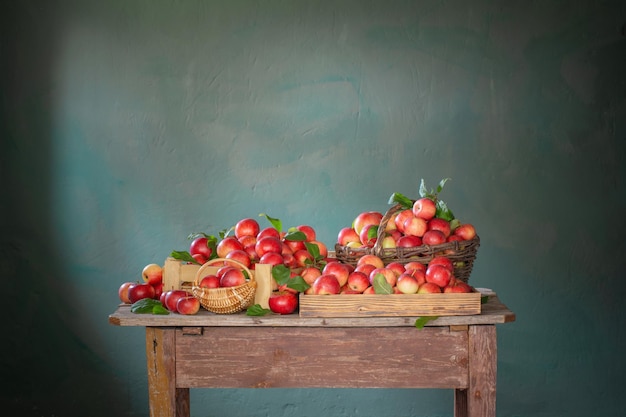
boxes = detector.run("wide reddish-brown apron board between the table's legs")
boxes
[176,327,469,388]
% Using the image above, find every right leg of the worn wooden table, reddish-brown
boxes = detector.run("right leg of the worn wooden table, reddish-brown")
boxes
[454,325,498,417]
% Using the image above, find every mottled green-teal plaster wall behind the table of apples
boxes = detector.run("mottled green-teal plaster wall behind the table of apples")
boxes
[0,0,626,417]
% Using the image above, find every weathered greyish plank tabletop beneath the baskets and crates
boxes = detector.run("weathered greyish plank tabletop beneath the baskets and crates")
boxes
[109,296,515,327]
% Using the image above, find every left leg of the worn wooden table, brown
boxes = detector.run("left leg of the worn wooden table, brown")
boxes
[146,327,189,417]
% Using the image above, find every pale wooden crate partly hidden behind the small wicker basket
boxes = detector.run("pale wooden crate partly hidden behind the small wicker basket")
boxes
[163,257,273,308]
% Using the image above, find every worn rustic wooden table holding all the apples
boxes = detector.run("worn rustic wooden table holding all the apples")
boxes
[109,295,515,417]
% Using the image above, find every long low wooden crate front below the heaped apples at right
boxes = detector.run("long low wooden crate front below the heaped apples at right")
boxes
[300,292,481,317]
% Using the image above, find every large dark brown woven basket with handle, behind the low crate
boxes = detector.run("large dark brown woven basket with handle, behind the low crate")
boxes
[335,204,480,282]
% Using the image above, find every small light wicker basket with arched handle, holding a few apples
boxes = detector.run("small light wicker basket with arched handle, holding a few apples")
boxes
[191,258,257,314]
